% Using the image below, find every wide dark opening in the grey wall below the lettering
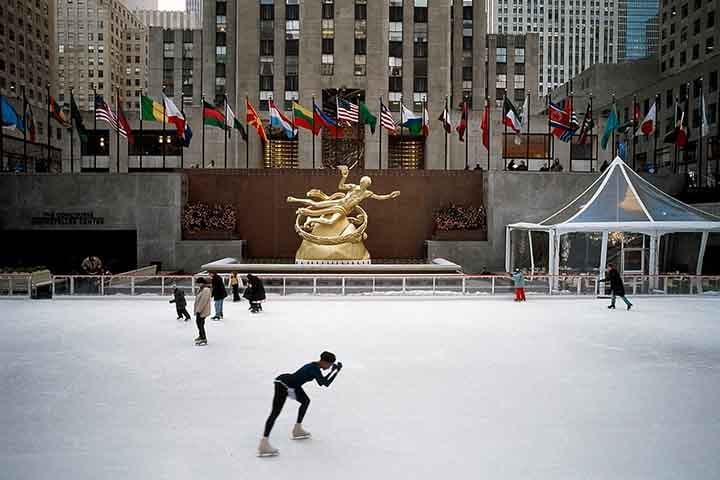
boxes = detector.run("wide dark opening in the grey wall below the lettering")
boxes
[0,230,137,274]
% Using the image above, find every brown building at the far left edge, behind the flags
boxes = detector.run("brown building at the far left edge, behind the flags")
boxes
[0,0,62,170]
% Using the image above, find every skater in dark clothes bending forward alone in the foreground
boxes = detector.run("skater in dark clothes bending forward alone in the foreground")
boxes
[258,352,342,457]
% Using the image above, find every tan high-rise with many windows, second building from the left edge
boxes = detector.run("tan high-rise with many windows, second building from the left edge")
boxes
[57,0,148,110]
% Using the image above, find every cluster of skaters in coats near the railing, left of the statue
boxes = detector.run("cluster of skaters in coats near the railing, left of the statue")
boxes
[170,272,265,345]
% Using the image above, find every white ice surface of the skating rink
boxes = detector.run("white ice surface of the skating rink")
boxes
[0,297,720,480]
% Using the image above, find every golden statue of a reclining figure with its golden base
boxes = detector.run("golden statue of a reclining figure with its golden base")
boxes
[287,165,400,263]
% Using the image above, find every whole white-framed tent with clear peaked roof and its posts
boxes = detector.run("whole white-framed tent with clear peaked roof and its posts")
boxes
[505,157,720,282]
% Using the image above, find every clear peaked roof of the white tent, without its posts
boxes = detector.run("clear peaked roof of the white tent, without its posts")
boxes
[508,157,720,234]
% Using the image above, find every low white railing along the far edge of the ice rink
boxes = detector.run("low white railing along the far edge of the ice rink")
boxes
[0,274,720,298]
